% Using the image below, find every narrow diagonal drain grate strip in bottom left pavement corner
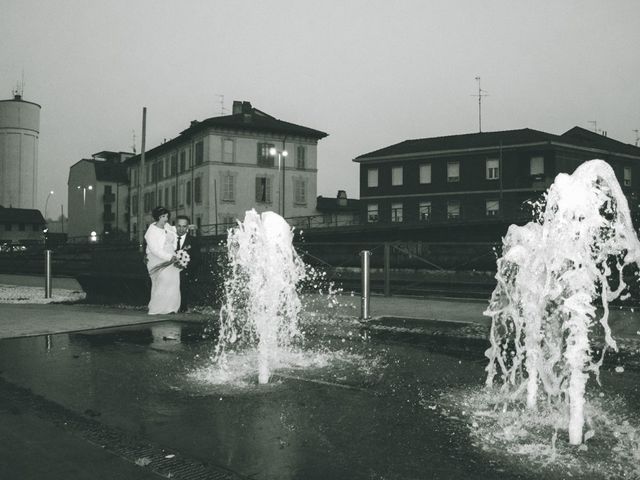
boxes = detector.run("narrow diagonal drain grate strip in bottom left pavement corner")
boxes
[0,378,247,480]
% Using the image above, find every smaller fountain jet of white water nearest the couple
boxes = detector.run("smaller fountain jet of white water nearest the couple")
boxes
[214,209,305,384]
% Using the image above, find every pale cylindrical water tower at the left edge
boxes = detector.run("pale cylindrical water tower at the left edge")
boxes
[0,95,40,208]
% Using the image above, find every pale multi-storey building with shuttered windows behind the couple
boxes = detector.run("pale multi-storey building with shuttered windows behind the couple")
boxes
[126,101,327,240]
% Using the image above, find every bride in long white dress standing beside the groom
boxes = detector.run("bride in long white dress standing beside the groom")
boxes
[144,207,180,315]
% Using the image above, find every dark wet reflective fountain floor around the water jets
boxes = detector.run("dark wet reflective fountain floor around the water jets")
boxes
[0,322,639,479]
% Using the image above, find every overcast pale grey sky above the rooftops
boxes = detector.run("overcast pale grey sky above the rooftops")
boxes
[0,0,640,215]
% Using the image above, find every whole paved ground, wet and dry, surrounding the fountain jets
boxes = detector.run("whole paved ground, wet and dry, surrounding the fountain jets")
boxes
[0,276,640,480]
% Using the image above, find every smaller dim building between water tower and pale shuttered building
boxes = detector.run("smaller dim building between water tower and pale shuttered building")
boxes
[67,151,134,242]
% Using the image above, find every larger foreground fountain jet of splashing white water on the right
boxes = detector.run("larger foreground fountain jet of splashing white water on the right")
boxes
[485,160,640,445]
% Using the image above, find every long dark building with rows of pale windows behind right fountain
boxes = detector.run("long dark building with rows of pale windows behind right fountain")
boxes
[354,127,640,231]
